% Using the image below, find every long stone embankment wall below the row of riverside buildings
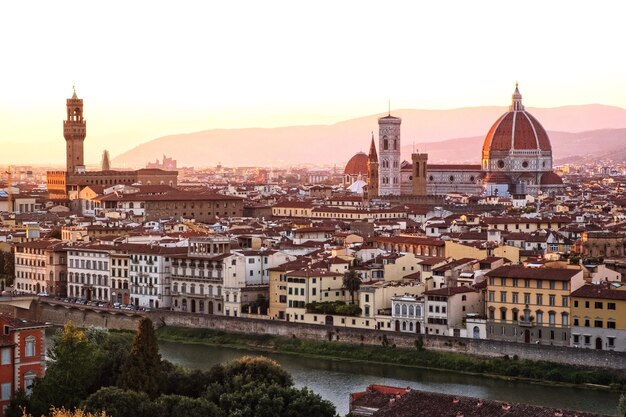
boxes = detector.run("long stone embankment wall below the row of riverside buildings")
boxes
[29,302,626,370]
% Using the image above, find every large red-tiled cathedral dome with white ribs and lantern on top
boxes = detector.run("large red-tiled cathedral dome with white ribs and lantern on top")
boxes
[483,84,552,153]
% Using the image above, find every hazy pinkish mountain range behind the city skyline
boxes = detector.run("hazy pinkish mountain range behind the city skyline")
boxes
[113,104,626,167]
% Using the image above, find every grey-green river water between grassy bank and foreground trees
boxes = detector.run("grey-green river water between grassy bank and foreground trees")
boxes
[159,342,619,415]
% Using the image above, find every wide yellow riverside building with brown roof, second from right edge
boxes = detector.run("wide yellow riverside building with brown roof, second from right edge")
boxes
[486,266,585,346]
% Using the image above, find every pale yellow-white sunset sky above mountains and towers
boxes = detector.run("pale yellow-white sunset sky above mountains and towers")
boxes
[0,0,626,164]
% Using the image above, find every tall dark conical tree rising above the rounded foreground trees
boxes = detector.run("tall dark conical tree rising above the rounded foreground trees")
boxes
[118,317,163,398]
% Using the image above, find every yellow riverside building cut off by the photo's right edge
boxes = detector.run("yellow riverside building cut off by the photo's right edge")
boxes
[571,282,626,352]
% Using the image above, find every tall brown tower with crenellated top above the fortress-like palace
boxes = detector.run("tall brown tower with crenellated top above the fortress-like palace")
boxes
[63,89,87,174]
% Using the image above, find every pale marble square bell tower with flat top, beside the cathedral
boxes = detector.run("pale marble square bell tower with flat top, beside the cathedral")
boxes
[378,112,402,196]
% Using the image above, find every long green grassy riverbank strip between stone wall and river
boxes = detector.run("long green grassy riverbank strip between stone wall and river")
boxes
[157,326,626,391]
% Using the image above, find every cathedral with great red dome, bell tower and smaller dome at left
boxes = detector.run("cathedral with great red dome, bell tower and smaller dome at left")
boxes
[343,85,563,198]
